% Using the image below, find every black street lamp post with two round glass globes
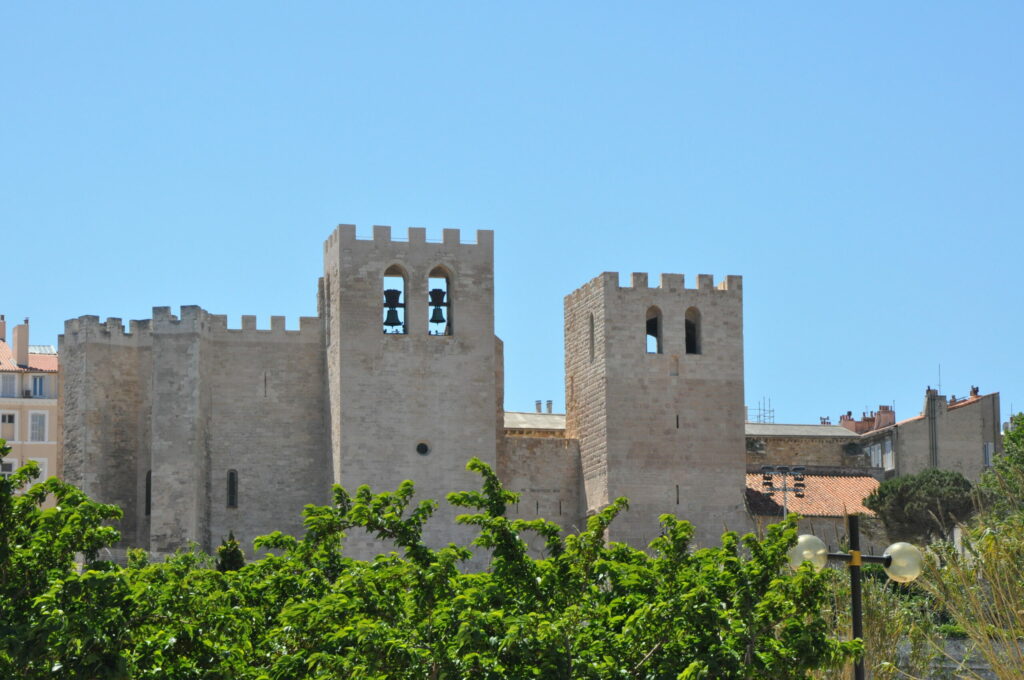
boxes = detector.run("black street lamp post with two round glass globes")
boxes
[790,515,924,680]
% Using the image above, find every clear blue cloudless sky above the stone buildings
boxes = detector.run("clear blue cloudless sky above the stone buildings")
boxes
[0,1,1024,423]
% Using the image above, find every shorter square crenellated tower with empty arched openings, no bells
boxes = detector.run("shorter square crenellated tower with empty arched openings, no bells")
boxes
[565,272,750,548]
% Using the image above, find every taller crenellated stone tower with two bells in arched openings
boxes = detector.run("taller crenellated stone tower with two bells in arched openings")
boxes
[318,224,501,558]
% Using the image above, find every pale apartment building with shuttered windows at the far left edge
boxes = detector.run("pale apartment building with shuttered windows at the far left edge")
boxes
[0,314,61,479]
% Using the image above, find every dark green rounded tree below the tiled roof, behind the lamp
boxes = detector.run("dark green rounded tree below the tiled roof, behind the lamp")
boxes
[864,468,975,543]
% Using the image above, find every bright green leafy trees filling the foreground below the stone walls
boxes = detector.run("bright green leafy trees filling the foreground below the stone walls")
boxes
[0,446,862,680]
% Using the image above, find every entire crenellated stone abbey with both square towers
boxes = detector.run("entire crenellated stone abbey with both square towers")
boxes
[60,225,750,557]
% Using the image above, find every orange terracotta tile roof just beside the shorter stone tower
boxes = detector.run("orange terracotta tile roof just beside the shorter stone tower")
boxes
[746,473,879,517]
